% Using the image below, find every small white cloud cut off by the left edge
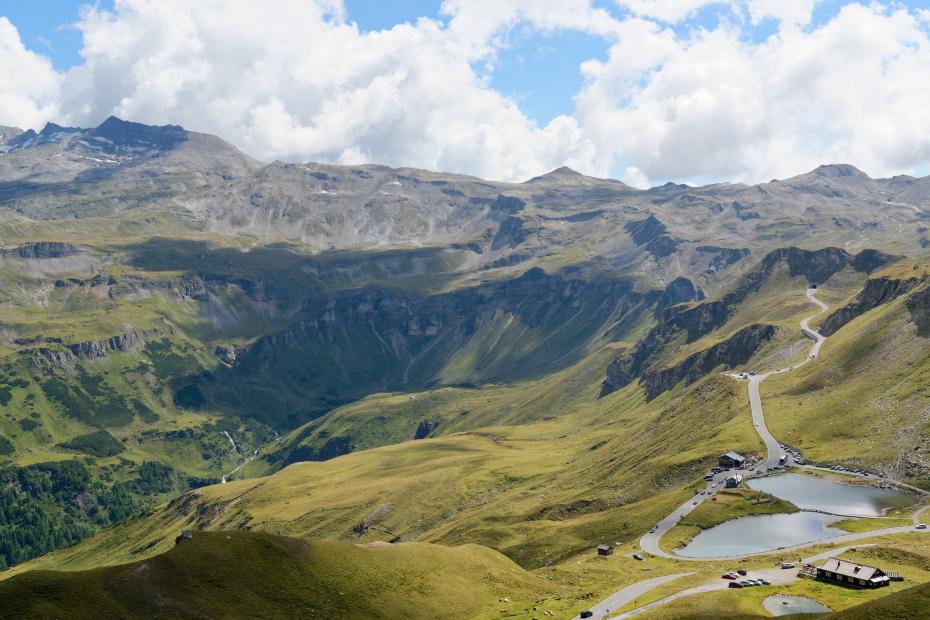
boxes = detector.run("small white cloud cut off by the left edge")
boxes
[0,17,60,127]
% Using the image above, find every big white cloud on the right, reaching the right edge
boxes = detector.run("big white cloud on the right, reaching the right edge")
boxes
[576,4,930,181]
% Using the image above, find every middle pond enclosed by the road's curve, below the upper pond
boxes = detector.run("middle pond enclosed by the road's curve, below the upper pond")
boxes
[675,512,846,558]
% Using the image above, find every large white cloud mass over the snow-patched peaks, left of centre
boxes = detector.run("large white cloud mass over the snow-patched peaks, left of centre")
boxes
[50,0,599,179]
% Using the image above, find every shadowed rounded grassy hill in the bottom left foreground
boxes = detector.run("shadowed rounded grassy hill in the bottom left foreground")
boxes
[0,532,554,618]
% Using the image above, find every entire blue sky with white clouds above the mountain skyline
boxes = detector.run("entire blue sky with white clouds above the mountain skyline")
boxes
[0,0,930,187]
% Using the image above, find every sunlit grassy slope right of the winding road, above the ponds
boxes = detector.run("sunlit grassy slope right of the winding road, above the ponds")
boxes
[762,265,930,485]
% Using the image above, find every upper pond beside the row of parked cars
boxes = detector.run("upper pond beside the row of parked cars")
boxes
[747,474,914,517]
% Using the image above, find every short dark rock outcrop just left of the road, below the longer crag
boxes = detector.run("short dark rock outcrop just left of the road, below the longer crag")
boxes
[641,323,775,400]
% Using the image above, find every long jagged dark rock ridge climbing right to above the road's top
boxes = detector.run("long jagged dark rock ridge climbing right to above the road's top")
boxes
[601,248,893,396]
